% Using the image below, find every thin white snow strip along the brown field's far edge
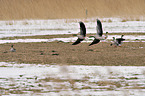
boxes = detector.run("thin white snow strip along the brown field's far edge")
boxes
[0,35,145,44]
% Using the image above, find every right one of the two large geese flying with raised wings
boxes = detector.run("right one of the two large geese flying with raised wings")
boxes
[89,19,108,46]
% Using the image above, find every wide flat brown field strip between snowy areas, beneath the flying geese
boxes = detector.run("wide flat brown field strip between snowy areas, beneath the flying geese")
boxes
[0,42,145,66]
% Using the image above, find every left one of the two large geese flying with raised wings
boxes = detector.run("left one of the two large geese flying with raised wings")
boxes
[72,22,86,45]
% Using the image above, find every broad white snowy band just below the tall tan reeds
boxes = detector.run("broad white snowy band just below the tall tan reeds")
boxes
[0,18,145,38]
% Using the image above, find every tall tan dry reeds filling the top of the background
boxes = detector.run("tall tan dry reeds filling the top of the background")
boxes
[0,0,145,20]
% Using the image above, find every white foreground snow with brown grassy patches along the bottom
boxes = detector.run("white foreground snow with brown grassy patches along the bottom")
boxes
[0,62,145,96]
